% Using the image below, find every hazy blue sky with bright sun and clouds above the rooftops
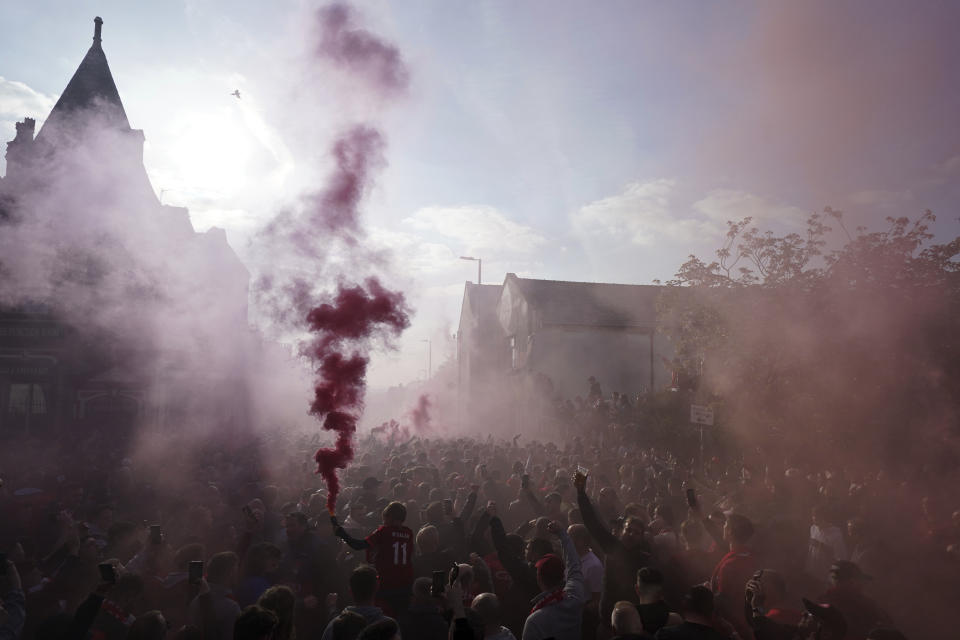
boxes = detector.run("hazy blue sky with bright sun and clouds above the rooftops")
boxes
[0,0,960,387]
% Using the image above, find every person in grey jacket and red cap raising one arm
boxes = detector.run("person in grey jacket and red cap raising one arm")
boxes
[522,522,586,640]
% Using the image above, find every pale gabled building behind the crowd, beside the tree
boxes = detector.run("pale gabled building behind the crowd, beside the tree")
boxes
[459,273,673,432]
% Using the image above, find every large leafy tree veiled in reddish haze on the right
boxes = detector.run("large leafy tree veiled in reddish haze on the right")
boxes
[658,208,960,470]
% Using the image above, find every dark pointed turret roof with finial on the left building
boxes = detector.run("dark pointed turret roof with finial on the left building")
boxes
[37,16,130,139]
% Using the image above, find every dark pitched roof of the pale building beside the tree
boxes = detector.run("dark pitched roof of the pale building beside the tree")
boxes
[507,274,662,328]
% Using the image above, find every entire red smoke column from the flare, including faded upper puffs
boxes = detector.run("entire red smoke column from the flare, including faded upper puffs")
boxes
[255,3,410,515]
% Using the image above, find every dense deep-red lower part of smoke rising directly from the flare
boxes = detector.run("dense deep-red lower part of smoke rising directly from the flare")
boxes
[307,278,410,515]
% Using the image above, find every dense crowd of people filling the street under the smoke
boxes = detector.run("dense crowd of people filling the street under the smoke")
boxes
[0,385,960,640]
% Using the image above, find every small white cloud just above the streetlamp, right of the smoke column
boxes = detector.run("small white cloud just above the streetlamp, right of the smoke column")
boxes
[403,205,547,255]
